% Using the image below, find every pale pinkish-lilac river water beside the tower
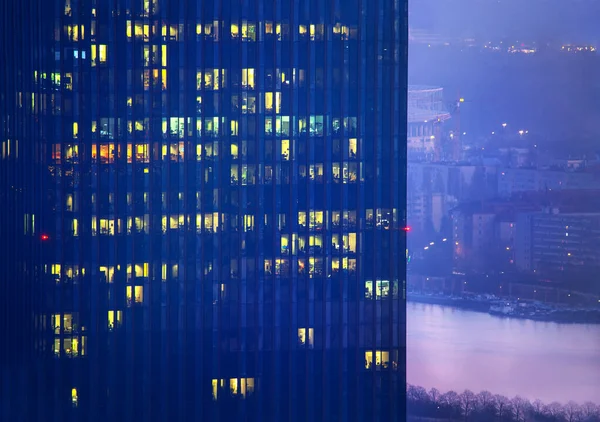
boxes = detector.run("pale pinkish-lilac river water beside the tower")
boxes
[407,302,600,403]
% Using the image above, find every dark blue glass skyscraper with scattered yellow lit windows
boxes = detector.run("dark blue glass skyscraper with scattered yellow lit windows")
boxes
[1,0,407,421]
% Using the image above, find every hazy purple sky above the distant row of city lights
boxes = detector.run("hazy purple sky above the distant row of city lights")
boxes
[409,0,600,43]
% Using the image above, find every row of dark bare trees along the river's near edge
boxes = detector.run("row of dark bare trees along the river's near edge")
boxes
[406,384,600,422]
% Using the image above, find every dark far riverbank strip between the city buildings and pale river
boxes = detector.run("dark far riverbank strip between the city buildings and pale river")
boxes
[406,292,600,324]
